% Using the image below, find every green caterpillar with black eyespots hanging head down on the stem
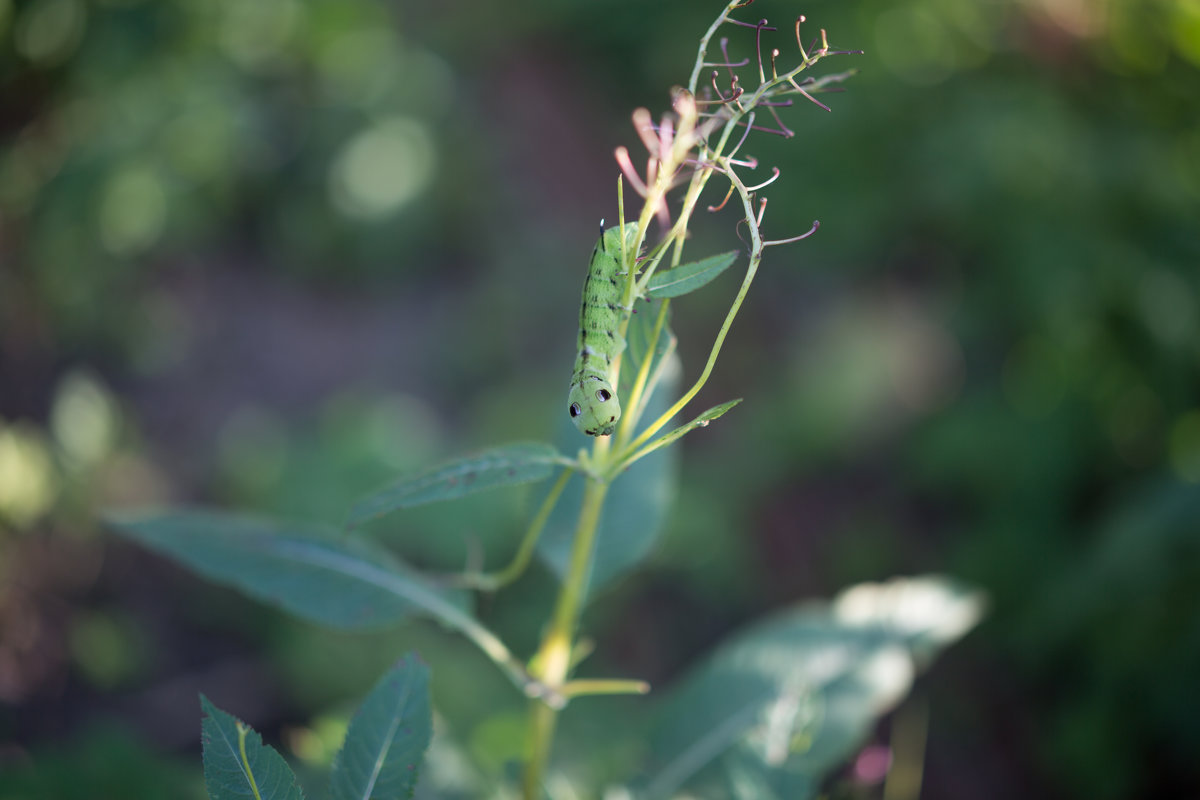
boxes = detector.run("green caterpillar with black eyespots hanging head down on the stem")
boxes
[566,222,637,437]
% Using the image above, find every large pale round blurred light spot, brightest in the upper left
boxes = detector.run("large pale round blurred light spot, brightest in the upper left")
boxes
[330,116,436,219]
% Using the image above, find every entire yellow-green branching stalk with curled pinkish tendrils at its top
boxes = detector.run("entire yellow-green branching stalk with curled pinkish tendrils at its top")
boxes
[516,6,852,800]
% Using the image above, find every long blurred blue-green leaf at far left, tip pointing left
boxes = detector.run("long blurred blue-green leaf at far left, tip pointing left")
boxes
[110,511,474,630]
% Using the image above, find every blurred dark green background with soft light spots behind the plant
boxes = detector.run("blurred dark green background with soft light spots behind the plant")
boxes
[0,0,1200,800]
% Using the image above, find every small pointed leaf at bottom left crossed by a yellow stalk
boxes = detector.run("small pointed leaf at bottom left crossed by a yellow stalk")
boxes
[200,694,304,800]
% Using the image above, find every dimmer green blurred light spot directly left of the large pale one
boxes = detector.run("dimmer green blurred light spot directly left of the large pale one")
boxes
[100,164,167,257]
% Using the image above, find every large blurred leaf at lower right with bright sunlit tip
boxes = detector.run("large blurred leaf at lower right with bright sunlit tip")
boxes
[641,577,982,799]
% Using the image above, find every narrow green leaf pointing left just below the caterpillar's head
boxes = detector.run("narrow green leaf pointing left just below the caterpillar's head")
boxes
[349,441,564,528]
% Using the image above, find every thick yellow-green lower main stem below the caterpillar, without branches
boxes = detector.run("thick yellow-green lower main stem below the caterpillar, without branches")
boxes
[523,474,608,800]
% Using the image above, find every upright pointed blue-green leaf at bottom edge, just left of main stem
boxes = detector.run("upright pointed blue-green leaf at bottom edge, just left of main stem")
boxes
[330,654,433,800]
